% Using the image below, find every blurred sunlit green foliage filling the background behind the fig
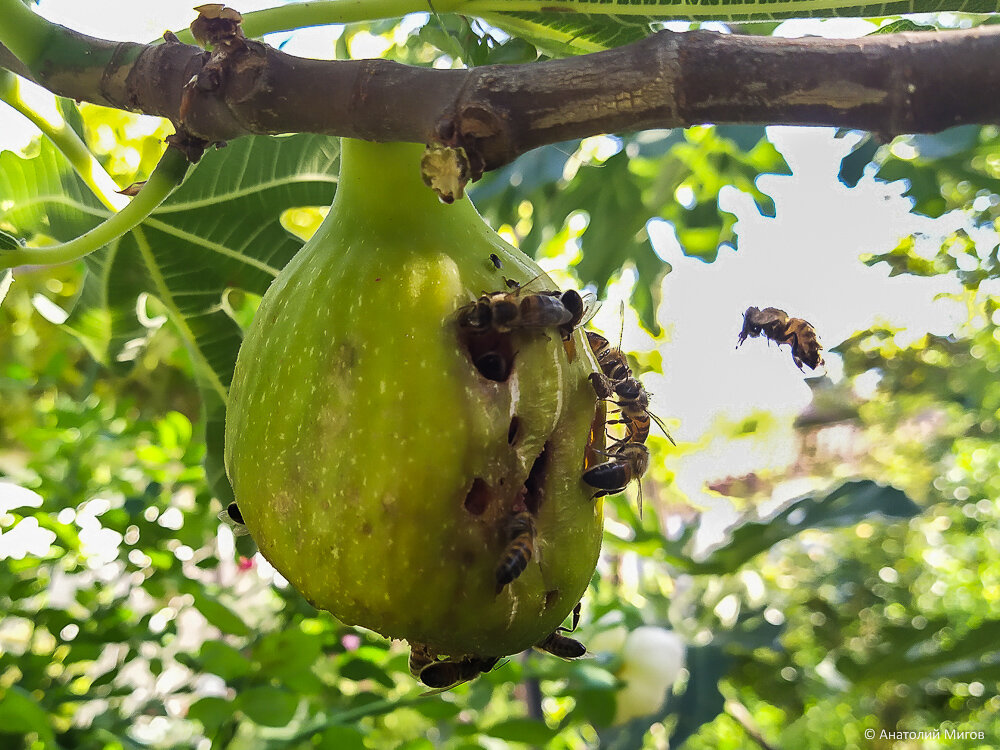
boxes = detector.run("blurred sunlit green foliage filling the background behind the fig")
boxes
[0,7,1000,750]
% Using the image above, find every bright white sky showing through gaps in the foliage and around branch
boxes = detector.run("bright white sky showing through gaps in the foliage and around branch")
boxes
[0,0,965,536]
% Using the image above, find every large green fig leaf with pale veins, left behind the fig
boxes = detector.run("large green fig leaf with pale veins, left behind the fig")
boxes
[0,135,339,502]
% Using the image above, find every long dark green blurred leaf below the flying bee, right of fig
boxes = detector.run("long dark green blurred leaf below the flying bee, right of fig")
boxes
[668,480,920,574]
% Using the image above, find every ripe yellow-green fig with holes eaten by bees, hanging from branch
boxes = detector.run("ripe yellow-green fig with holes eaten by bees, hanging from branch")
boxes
[225,139,604,656]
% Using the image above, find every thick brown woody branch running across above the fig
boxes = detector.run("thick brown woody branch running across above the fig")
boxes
[0,14,1000,169]
